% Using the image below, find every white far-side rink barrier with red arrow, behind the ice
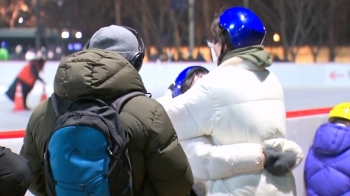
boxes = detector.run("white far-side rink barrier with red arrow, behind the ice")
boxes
[0,61,350,91]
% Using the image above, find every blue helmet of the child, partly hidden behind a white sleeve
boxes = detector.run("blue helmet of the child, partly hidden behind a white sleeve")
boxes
[173,65,209,98]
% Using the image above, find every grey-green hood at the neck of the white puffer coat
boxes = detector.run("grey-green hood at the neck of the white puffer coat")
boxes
[222,45,272,70]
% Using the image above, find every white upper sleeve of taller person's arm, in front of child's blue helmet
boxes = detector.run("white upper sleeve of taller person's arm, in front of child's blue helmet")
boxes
[162,77,216,141]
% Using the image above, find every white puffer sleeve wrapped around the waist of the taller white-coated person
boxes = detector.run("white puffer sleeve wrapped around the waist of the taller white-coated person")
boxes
[180,136,265,180]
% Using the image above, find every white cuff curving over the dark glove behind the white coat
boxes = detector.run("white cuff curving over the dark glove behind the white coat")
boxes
[263,138,303,169]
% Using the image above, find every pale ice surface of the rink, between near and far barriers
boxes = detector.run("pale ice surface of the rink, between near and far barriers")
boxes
[0,86,350,131]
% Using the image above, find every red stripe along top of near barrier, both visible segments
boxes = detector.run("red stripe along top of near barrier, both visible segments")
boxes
[0,108,332,139]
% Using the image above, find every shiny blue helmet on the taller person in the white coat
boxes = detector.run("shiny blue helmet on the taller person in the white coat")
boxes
[219,7,266,48]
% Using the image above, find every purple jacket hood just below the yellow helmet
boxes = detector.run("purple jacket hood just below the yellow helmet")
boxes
[313,123,350,155]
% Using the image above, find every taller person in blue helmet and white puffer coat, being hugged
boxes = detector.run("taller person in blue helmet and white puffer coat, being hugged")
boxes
[160,7,303,196]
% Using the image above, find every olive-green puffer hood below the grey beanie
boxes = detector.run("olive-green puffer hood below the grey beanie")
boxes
[54,49,146,100]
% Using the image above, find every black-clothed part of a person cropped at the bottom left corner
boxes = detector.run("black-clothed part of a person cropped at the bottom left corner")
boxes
[0,147,32,196]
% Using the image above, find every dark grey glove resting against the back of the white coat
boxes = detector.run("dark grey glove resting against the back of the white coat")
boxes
[264,148,297,176]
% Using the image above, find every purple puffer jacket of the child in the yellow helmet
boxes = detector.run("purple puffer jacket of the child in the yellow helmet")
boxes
[304,123,350,196]
